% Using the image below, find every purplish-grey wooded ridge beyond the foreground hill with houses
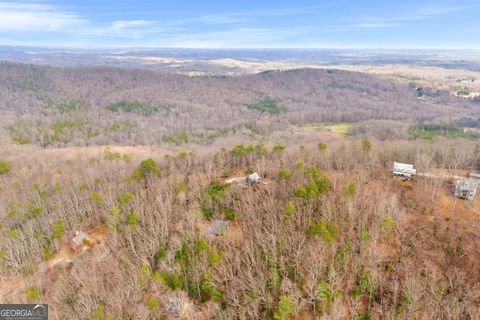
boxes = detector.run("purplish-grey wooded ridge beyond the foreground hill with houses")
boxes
[0,63,480,146]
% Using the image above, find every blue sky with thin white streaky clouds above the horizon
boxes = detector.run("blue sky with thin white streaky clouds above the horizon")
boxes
[0,0,480,49]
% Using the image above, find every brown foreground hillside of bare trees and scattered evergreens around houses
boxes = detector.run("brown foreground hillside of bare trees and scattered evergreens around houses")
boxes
[0,136,480,320]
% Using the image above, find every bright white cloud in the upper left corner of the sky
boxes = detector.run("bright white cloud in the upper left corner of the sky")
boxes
[0,2,87,32]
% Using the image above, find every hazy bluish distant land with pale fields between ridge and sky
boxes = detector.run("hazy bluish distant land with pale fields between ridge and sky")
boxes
[0,46,480,75]
